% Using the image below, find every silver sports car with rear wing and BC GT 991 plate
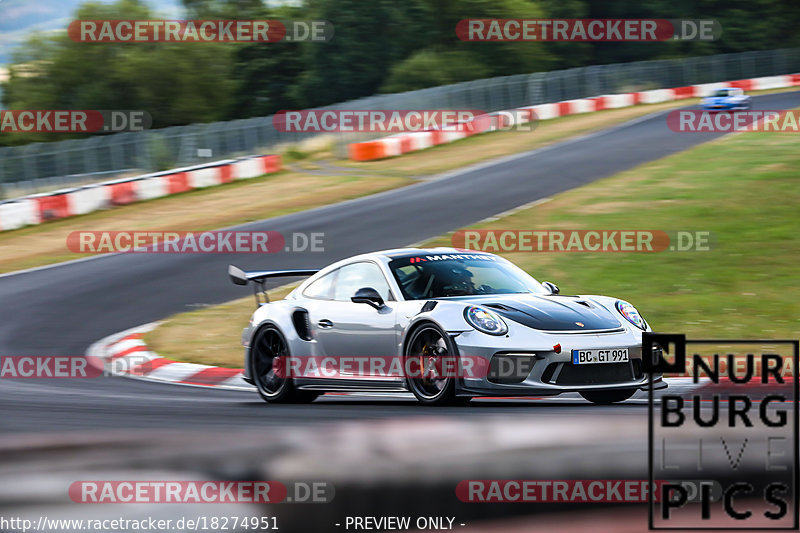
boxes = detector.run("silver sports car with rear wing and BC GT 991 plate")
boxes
[229,248,666,405]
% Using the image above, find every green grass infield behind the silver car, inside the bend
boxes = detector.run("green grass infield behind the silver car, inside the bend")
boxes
[149,119,800,367]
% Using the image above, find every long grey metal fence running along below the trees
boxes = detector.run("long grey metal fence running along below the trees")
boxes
[0,48,800,189]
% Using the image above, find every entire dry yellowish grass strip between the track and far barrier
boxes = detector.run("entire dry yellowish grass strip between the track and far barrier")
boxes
[6,89,788,273]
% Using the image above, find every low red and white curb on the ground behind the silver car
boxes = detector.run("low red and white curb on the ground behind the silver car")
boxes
[86,322,256,391]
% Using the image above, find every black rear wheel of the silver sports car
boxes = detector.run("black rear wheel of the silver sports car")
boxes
[249,326,319,403]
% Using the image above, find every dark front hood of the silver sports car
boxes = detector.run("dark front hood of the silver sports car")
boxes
[460,294,622,332]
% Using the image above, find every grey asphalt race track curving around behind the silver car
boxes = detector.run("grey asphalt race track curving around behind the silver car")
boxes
[0,92,800,437]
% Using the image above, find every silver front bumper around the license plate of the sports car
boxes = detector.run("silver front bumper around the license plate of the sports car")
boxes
[453,329,667,396]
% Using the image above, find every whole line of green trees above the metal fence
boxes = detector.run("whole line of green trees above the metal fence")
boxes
[0,0,800,144]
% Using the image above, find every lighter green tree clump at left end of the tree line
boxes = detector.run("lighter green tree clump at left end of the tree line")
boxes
[3,0,235,142]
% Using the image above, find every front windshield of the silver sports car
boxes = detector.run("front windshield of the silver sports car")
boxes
[389,254,549,300]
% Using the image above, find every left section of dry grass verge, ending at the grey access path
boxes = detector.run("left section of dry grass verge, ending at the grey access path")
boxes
[0,172,411,272]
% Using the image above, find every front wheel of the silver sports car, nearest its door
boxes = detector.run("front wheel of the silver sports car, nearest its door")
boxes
[403,323,460,405]
